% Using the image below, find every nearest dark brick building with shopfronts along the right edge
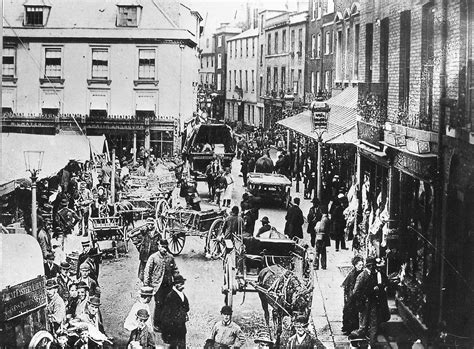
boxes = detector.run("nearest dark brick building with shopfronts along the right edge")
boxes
[356,0,474,344]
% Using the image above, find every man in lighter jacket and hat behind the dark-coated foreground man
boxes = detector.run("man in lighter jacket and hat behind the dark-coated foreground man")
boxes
[143,240,179,332]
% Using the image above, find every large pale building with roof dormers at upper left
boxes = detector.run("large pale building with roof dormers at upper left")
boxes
[2,0,201,155]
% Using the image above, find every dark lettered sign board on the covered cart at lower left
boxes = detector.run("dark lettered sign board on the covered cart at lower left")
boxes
[0,276,46,321]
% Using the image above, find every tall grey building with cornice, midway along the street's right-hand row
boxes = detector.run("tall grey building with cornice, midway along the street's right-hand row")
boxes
[260,11,307,129]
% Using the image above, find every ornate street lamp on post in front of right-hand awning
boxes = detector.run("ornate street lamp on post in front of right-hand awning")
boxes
[310,94,331,201]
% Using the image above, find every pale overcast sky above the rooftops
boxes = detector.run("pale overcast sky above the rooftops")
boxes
[182,0,297,35]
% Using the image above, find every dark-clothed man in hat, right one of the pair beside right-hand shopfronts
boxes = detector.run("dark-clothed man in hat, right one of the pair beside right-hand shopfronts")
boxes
[349,257,390,346]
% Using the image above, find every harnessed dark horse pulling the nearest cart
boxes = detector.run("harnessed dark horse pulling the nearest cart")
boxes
[258,265,313,346]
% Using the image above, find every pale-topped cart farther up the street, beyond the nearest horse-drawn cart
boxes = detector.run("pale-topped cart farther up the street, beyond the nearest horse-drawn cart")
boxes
[247,172,291,207]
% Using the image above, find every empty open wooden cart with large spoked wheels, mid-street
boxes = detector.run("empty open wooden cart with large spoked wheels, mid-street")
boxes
[156,200,227,258]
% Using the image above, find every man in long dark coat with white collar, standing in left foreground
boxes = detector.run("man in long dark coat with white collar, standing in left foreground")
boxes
[161,274,189,349]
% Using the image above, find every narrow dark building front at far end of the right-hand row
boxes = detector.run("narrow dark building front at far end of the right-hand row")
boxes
[213,23,242,121]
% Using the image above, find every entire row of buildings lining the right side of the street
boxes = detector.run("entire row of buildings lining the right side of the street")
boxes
[201,0,474,343]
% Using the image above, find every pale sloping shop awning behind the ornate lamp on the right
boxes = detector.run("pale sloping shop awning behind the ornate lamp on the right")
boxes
[278,87,357,144]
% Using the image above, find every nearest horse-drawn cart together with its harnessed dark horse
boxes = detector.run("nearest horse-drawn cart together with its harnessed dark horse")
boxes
[222,233,313,342]
